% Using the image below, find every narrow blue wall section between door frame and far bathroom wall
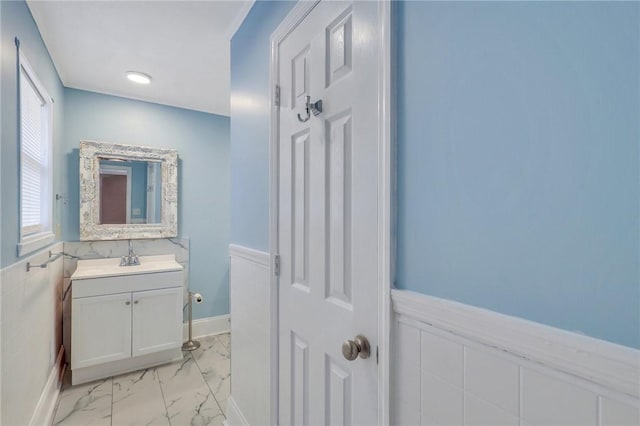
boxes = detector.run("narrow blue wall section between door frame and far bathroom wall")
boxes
[231,1,295,251]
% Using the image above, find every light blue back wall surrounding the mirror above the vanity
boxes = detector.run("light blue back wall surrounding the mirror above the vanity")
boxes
[63,88,230,318]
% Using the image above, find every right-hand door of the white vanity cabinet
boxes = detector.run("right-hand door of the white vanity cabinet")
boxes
[131,287,182,356]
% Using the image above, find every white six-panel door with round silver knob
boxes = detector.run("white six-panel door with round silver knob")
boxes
[277,1,379,426]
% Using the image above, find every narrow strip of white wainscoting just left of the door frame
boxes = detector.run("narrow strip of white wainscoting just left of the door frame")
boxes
[227,244,271,426]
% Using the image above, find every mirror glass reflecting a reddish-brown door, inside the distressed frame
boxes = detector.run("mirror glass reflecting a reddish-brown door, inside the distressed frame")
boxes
[99,157,162,224]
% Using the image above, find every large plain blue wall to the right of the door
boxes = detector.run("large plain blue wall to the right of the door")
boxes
[396,2,640,347]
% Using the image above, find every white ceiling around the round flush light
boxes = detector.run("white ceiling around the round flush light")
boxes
[25,0,253,115]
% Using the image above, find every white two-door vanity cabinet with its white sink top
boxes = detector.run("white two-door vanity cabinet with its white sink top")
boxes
[71,256,183,385]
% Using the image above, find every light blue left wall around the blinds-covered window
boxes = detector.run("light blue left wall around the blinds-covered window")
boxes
[0,1,64,267]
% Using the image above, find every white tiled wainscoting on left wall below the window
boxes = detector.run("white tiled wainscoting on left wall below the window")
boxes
[0,243,64,425]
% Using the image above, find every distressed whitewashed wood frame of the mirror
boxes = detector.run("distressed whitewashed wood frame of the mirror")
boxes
[80,141,178,241]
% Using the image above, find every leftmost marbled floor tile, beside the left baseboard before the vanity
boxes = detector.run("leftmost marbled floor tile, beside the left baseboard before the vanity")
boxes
[53,378,113,426]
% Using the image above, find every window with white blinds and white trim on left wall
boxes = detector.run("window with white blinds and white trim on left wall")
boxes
[18,54,54,256]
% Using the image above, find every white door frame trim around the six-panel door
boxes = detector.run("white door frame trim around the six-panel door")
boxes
[269,0,395,425]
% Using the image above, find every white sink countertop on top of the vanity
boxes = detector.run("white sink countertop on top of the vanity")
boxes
[71,254,182,280]
